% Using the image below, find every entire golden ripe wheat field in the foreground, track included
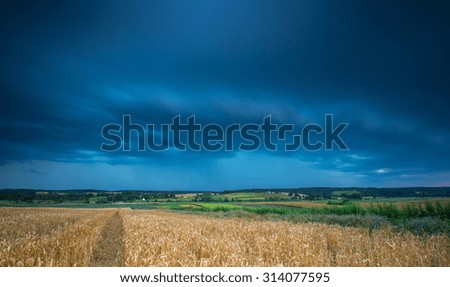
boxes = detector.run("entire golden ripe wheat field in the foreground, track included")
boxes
[0,208,450,266]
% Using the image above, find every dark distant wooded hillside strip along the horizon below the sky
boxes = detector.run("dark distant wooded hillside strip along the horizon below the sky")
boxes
[0,187,450,203]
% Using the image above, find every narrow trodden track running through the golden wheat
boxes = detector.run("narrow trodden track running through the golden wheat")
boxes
[89,211,123,267]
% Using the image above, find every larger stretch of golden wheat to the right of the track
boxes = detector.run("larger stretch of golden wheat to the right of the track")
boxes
[123,211,450,266]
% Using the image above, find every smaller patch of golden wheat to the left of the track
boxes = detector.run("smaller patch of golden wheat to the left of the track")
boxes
[0,208,114,266]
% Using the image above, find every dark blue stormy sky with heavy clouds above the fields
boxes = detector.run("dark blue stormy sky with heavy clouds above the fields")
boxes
[0,0,450,191]
